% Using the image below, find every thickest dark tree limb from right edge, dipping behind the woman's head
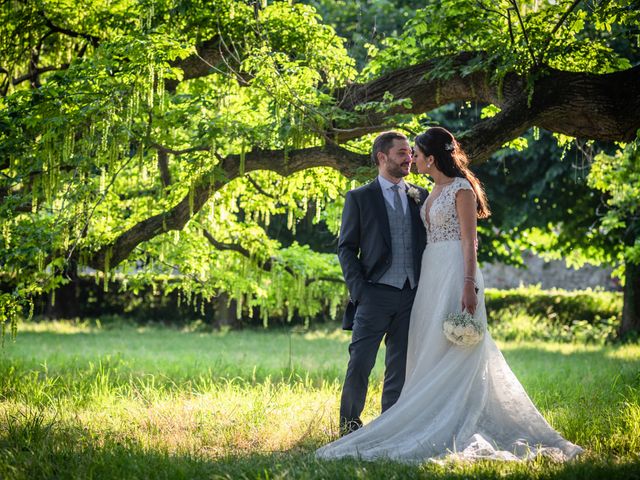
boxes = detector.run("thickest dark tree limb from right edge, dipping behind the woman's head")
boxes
[460,66,640,163]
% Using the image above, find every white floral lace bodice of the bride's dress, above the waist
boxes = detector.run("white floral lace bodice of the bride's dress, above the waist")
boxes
[420,177,472,243]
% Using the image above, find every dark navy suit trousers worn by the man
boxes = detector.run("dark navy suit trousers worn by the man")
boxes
[340,284,416,429]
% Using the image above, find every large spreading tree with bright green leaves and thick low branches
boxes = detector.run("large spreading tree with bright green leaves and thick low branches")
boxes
[0,0,640,336]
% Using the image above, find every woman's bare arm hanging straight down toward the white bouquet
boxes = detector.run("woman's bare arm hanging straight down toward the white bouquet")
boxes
[456,190,478,315]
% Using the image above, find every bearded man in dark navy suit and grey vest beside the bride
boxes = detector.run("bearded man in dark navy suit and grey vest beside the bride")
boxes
[338,132,427,435]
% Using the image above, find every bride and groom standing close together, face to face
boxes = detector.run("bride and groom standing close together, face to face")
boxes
[316,127,582,462]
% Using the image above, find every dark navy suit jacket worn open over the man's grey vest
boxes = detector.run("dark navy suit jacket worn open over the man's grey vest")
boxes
[338,178,428,330]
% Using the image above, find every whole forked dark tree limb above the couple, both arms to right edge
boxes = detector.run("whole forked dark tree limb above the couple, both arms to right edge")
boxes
[329,53,640,162]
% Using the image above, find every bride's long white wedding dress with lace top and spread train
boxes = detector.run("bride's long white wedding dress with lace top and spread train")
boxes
[316,178,582,463]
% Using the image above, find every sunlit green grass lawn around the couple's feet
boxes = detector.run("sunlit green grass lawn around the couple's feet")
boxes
[0,322,640,479]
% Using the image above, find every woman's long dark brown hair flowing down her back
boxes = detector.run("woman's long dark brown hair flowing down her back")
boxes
[415,127,491,218]
